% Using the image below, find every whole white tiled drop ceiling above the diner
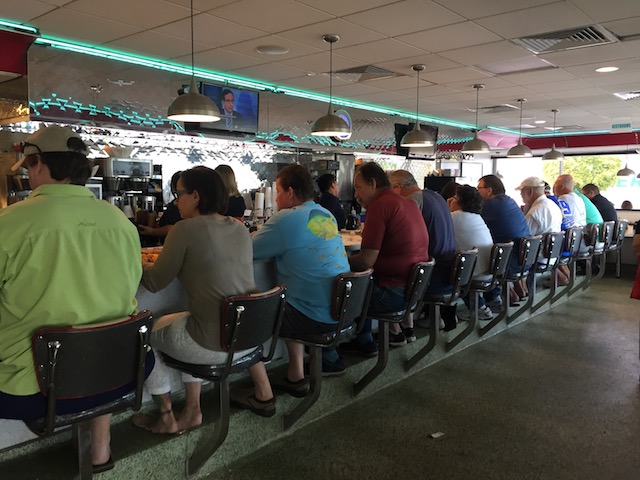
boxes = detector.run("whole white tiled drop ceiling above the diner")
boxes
[0,0,640,133]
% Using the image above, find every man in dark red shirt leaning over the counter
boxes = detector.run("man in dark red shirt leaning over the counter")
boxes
[343,162,429,357]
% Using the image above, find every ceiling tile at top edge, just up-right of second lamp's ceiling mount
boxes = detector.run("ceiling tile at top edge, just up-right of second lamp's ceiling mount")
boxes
[344,0,465,36]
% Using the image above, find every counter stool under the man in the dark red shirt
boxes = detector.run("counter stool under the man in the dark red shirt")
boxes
[353,260,436,397]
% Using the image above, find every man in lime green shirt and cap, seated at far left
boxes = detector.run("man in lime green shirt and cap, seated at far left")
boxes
[0,126,142,471]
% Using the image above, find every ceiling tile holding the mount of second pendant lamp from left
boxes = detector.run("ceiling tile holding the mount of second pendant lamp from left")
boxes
[279,18,385,50]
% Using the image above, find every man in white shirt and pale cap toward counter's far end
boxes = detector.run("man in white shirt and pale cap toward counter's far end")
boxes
[516,177,562,235]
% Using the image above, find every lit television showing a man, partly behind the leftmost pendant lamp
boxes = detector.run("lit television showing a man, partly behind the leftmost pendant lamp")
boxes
[184,82,259,135]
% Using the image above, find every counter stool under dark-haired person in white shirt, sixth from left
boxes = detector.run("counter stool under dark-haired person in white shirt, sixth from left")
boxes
[445,242,513,351]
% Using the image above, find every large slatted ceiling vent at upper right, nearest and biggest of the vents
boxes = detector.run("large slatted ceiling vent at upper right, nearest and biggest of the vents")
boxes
[511,25,620,55]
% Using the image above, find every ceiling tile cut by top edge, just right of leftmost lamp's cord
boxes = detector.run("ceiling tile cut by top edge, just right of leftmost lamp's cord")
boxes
[213,0,331,33]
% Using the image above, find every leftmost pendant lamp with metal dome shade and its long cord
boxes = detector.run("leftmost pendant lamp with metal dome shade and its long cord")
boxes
[167,0,220,122]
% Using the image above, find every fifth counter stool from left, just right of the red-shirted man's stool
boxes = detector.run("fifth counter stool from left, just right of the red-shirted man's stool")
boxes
[404,249,478,372]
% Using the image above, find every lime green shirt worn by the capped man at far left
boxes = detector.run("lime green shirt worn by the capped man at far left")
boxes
[0,184,142,395]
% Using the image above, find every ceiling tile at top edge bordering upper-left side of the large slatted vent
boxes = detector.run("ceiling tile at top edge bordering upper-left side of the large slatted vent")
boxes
[476,2,591,38]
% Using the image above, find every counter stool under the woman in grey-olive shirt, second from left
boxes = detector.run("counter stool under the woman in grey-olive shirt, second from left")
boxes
[162,285,285,477]
